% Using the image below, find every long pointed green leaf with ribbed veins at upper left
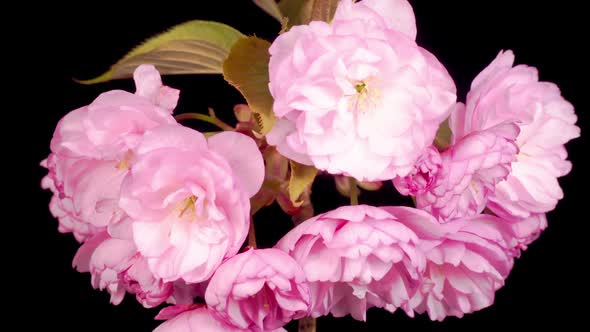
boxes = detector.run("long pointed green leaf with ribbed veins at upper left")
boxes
[78,20,244,84]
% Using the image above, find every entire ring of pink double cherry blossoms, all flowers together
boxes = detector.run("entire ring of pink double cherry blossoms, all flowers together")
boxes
[42,0,580,332]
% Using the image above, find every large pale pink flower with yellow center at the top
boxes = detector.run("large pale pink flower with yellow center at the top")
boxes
[267,0,456,181]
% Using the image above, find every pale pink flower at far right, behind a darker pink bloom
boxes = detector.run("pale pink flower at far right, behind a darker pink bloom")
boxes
[450,51,580,233]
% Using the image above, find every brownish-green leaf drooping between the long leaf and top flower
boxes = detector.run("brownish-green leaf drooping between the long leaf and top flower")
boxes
[223,37,276,135]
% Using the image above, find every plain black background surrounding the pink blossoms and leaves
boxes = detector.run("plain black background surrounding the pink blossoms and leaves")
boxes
[20,0,590,331]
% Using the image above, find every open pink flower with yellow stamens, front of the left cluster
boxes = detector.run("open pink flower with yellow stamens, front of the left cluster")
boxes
[119,125,264,283]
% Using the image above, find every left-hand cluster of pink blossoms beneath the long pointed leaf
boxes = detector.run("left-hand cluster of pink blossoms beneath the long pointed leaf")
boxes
[42,65,264,307]
